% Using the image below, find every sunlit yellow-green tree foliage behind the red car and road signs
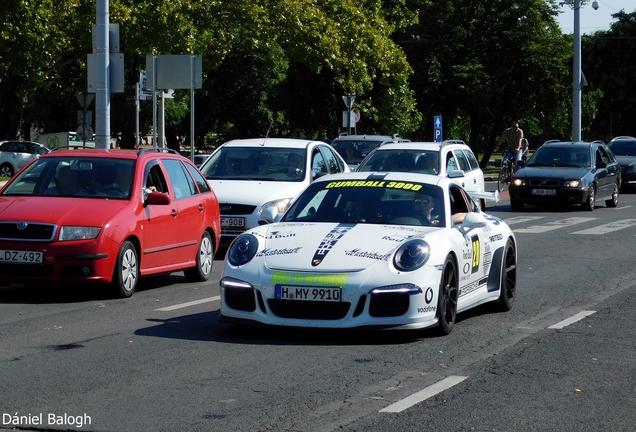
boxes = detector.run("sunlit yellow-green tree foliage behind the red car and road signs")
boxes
[0,0,420,145]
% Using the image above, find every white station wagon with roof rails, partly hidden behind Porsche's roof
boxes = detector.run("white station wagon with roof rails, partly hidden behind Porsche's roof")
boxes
[356,140,499,210]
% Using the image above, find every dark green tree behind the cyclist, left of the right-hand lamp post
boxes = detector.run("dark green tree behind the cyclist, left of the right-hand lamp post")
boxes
[396,0,571,163]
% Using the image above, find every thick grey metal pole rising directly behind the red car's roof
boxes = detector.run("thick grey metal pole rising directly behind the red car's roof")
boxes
[95,0,110,149]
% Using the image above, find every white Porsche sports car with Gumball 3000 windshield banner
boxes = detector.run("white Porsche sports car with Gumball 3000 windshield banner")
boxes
[218,172,517,334]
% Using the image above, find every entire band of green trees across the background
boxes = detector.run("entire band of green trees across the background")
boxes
[0,0,636,164]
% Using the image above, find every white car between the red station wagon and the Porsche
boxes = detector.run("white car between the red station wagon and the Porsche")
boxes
[201,138,350,241]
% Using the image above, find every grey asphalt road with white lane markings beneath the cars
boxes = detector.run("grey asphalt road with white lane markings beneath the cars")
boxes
[0,189,636,432]
